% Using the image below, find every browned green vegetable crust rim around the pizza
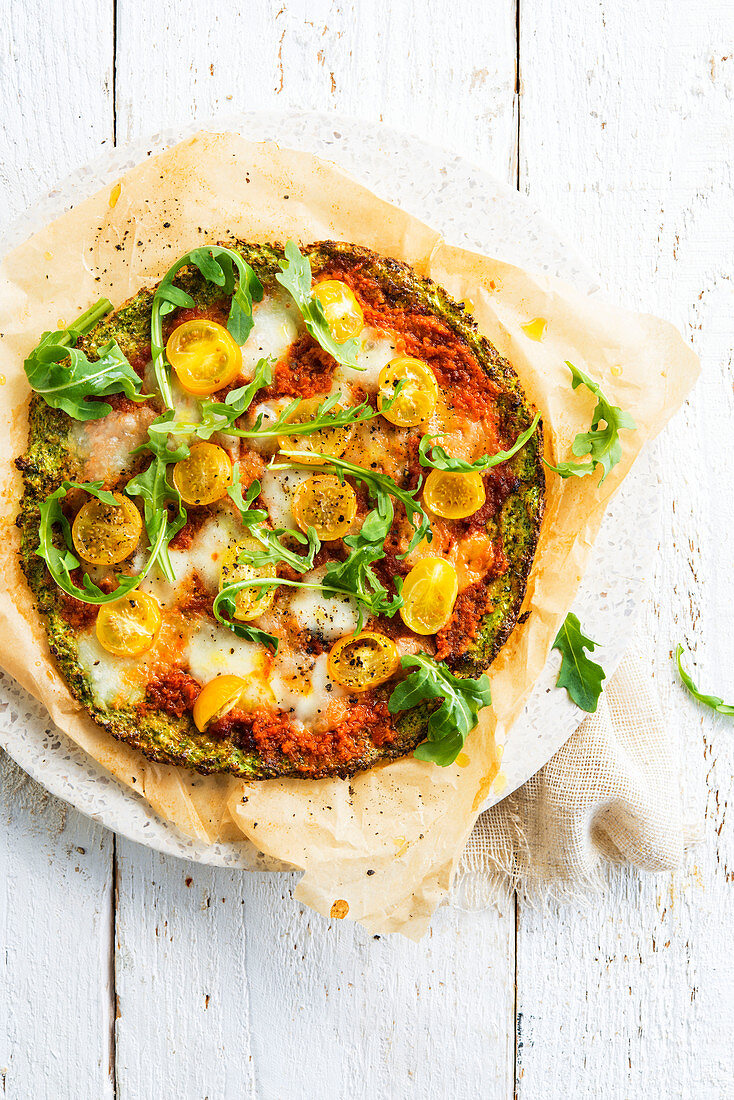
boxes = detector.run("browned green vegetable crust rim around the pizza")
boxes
[17,241,545,779]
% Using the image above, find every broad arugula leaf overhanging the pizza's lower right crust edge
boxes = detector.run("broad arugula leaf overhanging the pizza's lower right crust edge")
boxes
[387,653,492,768]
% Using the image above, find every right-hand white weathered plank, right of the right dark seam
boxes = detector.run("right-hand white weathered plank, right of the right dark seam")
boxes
[517,0,734,1098]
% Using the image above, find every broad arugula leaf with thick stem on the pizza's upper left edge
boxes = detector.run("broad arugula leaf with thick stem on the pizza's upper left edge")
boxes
[23,298,146,420]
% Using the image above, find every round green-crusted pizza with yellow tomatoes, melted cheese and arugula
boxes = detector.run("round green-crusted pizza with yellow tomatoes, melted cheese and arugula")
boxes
[17,241,545,779]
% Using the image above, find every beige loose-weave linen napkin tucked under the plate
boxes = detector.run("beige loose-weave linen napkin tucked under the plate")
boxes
[451,642,700,909]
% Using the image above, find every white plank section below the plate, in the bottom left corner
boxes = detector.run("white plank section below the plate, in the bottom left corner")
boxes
[0,754,113,1100]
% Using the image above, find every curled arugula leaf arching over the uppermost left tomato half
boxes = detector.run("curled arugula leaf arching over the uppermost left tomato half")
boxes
[151,244,263,409]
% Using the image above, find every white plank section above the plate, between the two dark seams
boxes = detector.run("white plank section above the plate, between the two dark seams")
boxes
[117,0,516,172]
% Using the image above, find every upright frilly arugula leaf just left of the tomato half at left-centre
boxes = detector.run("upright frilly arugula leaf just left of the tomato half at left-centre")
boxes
[125,409,189,584]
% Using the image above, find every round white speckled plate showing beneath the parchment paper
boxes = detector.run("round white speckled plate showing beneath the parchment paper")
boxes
[0,112,659,867]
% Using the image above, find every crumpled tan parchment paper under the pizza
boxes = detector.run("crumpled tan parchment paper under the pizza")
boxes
[0,133,698,938]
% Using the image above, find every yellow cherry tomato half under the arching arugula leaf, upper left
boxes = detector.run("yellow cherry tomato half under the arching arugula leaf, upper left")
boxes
[166,318,242,397]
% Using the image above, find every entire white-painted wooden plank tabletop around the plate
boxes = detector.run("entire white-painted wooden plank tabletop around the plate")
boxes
[0,0,734,1100]
